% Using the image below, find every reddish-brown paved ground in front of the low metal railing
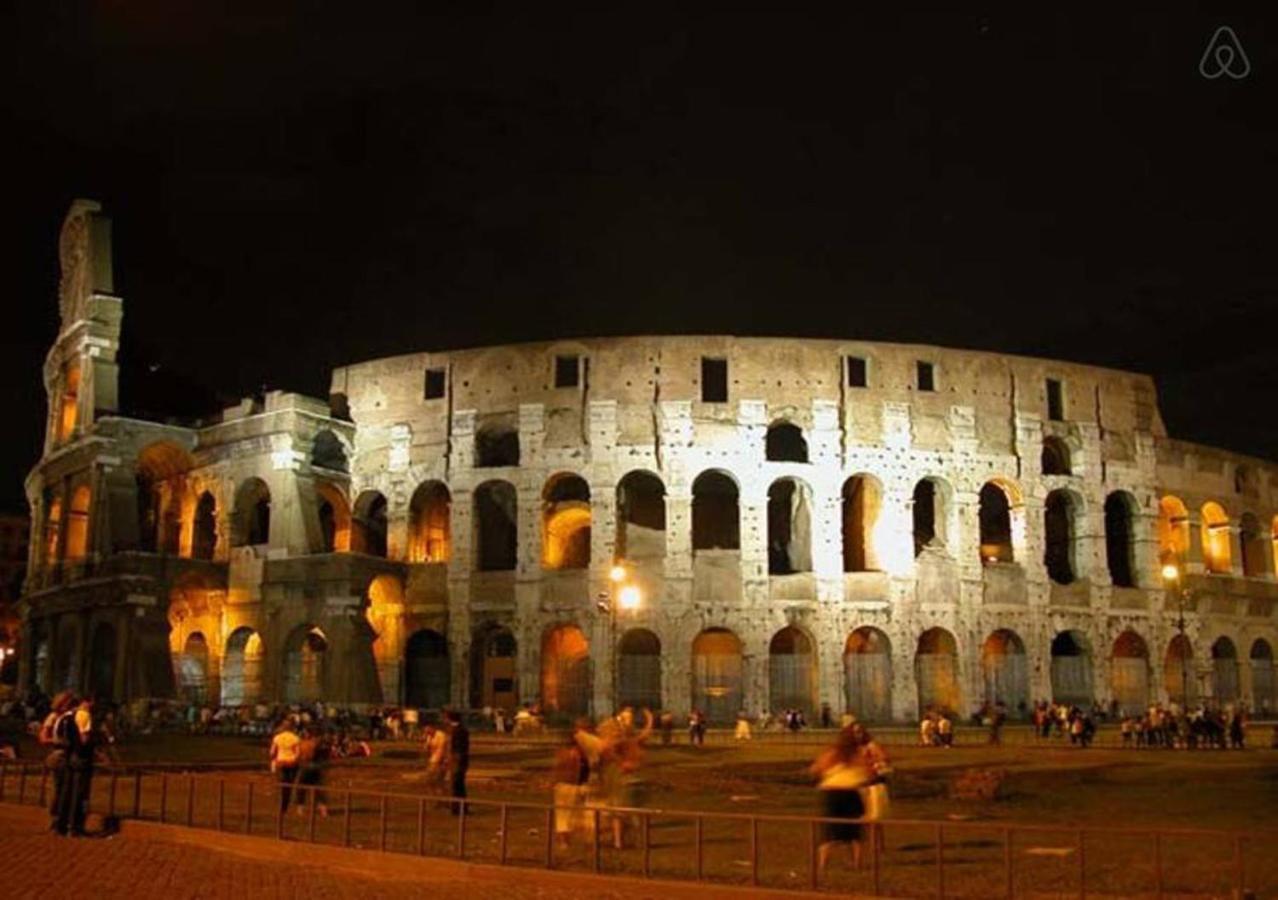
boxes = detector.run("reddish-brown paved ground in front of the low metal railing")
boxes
[0,804,810,900]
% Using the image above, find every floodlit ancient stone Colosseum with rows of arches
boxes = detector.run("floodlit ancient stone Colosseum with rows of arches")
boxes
[20,201,1278,721]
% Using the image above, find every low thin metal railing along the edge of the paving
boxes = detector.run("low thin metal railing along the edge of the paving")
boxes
[0,761,1278,897]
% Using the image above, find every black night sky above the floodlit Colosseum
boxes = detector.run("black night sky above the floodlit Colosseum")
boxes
[0,7,1278,506]
